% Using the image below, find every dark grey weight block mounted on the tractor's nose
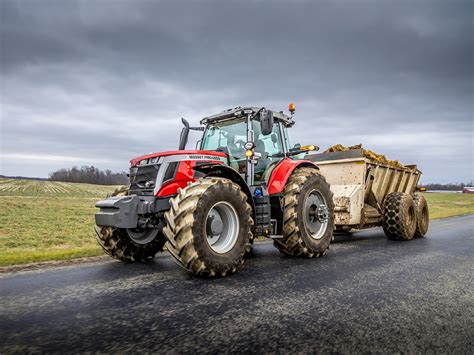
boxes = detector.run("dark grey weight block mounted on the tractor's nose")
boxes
[95,195,170,228]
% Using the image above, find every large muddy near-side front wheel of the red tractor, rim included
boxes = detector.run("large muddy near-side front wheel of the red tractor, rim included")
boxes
[163,177,254,277]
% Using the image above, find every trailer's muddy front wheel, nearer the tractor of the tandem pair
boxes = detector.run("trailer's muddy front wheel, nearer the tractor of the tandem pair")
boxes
[382,192,416,240]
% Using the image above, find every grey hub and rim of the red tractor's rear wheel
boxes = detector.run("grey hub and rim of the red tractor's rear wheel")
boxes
[304,190,329,239]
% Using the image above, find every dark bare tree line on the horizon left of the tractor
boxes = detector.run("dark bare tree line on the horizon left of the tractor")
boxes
[49,165,128,185]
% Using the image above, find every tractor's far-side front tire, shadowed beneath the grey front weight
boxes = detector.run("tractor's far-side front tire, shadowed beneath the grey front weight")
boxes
[95,186,166,262]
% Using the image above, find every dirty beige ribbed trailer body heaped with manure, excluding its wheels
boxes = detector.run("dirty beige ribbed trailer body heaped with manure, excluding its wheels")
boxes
[306,149,421,230]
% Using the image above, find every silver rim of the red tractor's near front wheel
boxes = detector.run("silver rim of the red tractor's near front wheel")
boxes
[206,201,239,254]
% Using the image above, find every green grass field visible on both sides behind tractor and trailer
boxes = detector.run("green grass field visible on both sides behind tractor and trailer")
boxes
[0,179,474,266]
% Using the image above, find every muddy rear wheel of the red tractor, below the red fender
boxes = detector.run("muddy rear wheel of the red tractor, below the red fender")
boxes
[273,168,334,258]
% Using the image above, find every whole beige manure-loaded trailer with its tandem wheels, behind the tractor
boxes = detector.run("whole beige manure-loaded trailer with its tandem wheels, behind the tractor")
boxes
[305,149,429,239]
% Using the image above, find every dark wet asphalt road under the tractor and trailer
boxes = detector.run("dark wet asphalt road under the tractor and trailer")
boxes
[0,215,474,354]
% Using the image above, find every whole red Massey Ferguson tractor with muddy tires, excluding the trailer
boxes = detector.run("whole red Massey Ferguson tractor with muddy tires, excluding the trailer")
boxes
[95,104,334,276]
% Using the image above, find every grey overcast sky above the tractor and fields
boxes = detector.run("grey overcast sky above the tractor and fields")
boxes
[0,0,474,182]
